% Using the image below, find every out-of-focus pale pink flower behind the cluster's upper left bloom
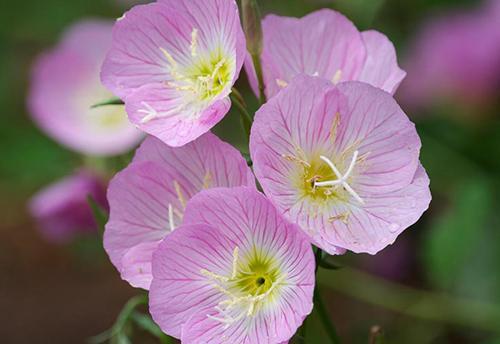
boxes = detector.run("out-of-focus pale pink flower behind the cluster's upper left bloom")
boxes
[29,20,142,155]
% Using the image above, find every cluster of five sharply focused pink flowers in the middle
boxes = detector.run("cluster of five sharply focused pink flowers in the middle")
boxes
[29,0,431,343]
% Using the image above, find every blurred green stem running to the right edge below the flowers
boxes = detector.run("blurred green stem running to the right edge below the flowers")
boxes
[317,268,500,333]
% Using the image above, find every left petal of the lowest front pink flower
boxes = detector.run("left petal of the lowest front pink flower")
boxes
[149,224,235,338]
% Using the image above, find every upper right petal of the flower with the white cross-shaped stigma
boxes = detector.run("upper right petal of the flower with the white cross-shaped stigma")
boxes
[335,82,421,194]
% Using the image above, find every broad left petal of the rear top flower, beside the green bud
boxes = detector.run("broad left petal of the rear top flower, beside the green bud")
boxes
[246,9,366,98]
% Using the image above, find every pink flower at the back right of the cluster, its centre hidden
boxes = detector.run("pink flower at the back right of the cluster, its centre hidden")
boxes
[245,9,406,98]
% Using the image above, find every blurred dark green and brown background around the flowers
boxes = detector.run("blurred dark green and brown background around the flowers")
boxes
[0,0,500,344]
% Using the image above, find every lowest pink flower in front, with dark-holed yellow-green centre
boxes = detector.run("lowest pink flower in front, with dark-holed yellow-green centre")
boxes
[149,187,314,344]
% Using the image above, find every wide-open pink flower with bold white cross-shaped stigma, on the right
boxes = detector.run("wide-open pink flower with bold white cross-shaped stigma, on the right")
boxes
[250,75,431,254]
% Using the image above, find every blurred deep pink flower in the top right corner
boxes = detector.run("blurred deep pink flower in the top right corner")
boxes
[400,0,500,107]
